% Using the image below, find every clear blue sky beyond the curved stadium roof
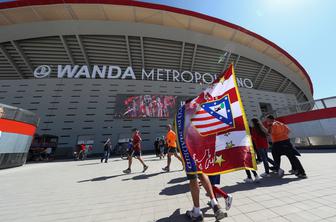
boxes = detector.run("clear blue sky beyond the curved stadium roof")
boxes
[0,0,336,99]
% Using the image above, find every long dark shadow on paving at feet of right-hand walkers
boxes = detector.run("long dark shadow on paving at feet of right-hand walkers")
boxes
[222,178,300,193]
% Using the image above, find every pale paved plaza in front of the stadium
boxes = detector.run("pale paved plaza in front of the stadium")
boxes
[0,152,336,222]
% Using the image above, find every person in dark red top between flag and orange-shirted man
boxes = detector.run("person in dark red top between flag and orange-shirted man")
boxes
[251,118,271,177]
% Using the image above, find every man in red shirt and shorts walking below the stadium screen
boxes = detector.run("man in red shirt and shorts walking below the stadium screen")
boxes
[123,128,148,174]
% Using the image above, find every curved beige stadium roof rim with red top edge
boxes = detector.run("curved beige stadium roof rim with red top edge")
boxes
[0,0,313,97]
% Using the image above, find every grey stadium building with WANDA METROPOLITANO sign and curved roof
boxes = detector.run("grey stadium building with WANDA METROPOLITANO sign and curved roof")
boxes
[0,0,313,154]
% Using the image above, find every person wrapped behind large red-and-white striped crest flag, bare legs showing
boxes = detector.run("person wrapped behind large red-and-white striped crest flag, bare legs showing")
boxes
[176,64,256,221]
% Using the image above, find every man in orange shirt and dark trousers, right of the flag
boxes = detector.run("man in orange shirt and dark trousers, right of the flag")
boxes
[266,115,307,178]
